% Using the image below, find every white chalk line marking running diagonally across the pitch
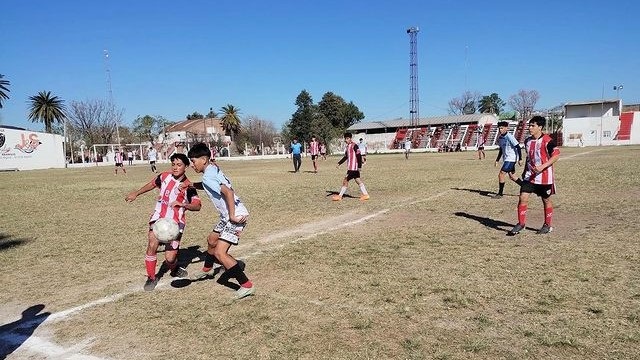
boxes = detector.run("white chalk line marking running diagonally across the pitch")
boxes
[0,149,604,360]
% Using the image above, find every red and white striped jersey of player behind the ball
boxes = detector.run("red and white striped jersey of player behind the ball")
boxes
[149,172,200,225]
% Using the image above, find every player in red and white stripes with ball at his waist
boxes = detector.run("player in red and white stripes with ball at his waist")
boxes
[125,153,201,291]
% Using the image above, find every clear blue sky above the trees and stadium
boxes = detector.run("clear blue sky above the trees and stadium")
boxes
[0,0,640,130]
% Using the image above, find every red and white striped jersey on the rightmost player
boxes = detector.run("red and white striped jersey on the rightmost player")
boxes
[523,134,560,185]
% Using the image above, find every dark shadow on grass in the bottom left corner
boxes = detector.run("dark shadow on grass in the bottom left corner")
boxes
[0,304,51,359]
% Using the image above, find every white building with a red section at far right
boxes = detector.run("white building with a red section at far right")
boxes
[562,99,640,146]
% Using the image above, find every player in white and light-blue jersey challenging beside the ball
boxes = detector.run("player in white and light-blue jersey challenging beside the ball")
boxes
[188,143,255,299]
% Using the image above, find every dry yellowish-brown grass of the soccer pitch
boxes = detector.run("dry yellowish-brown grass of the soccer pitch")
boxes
[0,146,640,359]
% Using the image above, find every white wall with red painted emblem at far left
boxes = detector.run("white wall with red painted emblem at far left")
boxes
[0,128,65,170]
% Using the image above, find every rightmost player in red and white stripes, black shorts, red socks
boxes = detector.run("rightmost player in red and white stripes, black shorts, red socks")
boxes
[507,116,560,236]
